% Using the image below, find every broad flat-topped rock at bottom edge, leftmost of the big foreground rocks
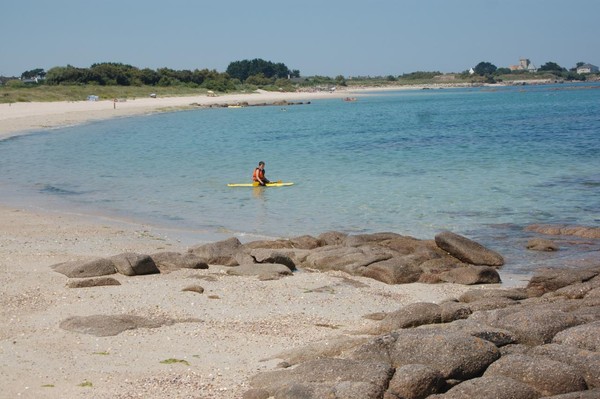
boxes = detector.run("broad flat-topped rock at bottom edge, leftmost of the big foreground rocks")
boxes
[250,358,393,399]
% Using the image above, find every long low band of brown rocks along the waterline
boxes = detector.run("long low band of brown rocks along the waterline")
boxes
[53,232,504,286]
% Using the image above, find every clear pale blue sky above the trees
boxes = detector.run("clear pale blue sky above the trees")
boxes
[0,0,600,77]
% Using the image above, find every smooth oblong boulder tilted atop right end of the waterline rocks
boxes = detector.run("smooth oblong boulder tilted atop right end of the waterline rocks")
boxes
[435,231,504,266]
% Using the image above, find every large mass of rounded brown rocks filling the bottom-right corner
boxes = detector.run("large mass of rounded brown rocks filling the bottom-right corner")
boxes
[244,265,600,399]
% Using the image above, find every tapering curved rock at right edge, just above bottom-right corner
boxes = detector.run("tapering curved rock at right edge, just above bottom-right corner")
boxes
[528,344,600,388]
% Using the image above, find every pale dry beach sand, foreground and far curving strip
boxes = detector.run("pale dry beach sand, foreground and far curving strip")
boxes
[0,89,491,398]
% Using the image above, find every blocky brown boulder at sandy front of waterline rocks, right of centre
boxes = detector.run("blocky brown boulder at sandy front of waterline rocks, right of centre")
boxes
[362,255,422,284]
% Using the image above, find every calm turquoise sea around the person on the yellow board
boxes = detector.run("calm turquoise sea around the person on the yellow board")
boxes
[0,83,600,284]
